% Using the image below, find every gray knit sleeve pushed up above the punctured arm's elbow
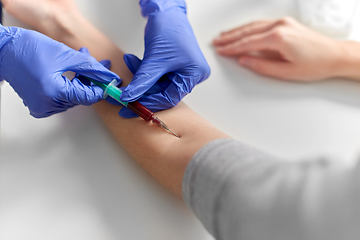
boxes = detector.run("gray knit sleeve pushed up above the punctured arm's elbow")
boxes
[183,139,360,240]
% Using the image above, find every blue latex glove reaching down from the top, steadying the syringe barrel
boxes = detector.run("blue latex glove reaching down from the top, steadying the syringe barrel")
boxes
[120,0,210,117]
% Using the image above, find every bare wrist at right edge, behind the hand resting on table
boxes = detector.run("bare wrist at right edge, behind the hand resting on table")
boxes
[333,41,360,80]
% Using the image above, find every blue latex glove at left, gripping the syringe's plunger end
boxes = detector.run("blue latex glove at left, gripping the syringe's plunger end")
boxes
[0,25,121,118]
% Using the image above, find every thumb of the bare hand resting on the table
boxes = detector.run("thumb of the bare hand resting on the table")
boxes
[238,56,291,78]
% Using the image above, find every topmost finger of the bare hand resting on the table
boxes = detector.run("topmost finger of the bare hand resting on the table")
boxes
[213,20,276,46]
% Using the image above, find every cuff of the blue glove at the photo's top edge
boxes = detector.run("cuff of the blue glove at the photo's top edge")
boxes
[140,0,186,17]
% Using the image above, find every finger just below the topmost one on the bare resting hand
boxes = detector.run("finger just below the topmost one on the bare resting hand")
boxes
[216,31,282,56]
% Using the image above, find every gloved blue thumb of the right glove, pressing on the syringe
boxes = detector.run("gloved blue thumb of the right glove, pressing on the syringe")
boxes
[120,60,164,102]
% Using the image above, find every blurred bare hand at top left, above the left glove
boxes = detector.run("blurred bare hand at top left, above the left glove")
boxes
[2,0,78,36]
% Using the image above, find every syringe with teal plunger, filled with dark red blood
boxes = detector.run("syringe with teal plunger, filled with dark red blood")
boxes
[85,77,180,138]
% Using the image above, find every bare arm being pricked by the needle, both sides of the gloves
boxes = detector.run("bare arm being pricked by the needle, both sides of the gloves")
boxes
[2,0,228,196]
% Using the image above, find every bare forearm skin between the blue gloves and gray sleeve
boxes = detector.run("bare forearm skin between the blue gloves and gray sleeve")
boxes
[95,102,228,196]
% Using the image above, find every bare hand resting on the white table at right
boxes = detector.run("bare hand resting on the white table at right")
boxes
[214,17,359,81]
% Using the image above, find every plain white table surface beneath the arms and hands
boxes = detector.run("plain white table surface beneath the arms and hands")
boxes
[0,0,360,240]
